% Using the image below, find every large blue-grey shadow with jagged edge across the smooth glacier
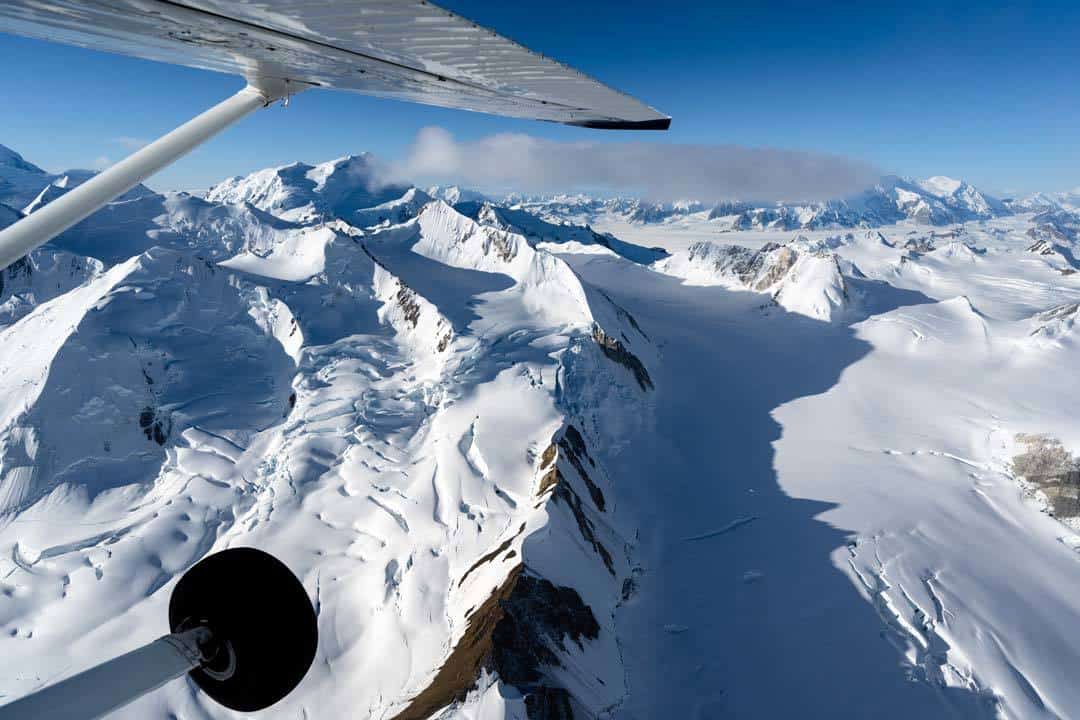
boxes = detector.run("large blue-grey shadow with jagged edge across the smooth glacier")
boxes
[566,256,994,720]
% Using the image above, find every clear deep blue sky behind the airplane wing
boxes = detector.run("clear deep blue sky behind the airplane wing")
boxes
[0,0,1080,193]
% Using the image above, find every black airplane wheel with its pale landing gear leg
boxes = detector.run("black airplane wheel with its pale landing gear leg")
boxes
[0,547,319,720]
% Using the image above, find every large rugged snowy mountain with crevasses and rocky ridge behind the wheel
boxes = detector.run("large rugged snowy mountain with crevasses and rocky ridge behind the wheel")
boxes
[0,144,656,718]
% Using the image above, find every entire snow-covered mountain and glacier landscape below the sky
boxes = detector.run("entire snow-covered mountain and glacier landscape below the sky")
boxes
[0,142,1080,720]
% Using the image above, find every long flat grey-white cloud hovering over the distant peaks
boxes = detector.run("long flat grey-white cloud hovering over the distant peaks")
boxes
[391,127,881,202]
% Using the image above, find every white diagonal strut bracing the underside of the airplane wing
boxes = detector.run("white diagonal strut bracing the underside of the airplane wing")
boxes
[0,81,307,269]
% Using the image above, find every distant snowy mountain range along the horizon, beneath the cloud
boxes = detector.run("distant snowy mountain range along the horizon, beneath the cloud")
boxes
[8,146,1080,239]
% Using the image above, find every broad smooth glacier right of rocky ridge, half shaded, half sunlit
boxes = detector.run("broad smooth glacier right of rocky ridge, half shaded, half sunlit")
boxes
[571,213,1080,718]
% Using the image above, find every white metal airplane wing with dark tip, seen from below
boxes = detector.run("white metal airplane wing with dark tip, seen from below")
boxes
[0,0,671,130]
